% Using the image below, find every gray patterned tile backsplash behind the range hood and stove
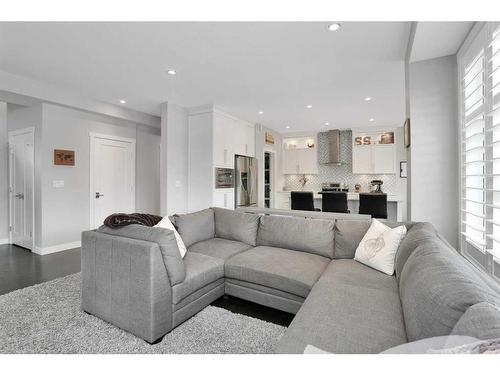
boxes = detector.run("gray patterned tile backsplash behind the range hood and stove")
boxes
[284,130,405,194]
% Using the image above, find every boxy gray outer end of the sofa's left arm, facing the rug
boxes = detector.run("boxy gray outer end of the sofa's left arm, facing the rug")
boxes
[81,231,172,343]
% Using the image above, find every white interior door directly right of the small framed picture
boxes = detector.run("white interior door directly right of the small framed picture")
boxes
[90,134,135,228]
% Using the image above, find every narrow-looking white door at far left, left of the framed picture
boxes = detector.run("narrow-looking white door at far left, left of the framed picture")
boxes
[9,128,35,250]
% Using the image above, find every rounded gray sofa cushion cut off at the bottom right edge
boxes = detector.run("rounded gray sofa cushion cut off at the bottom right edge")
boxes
[451,302,500,340]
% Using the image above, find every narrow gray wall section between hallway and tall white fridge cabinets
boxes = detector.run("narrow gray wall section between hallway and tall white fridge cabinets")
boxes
[160,103,188,215]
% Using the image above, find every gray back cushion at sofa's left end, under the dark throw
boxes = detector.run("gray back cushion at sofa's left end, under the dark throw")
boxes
[98,224,186,285]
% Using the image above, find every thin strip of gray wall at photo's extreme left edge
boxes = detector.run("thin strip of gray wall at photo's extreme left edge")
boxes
[0,102,9,244]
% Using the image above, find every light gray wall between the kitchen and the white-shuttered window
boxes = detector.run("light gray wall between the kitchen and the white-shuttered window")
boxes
[410,56,459,247]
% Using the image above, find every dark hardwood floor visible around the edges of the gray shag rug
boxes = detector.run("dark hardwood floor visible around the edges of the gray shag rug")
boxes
[0,245,294,326]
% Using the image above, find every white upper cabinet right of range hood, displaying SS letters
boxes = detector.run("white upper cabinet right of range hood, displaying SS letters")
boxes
[352,130,396,174]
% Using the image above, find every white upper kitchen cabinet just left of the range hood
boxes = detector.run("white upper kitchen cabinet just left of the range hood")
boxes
[283,136,318,174]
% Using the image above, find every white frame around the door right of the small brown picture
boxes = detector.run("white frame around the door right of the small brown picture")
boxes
[89,132,137,229]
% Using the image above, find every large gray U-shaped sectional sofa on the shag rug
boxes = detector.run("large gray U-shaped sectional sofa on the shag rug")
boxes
[82,208,500,353]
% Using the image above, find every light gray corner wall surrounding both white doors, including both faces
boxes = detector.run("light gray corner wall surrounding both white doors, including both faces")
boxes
[0,103,160,254]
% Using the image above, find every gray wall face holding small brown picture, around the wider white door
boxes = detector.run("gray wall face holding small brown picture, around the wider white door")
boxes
[40,104,160,248]
